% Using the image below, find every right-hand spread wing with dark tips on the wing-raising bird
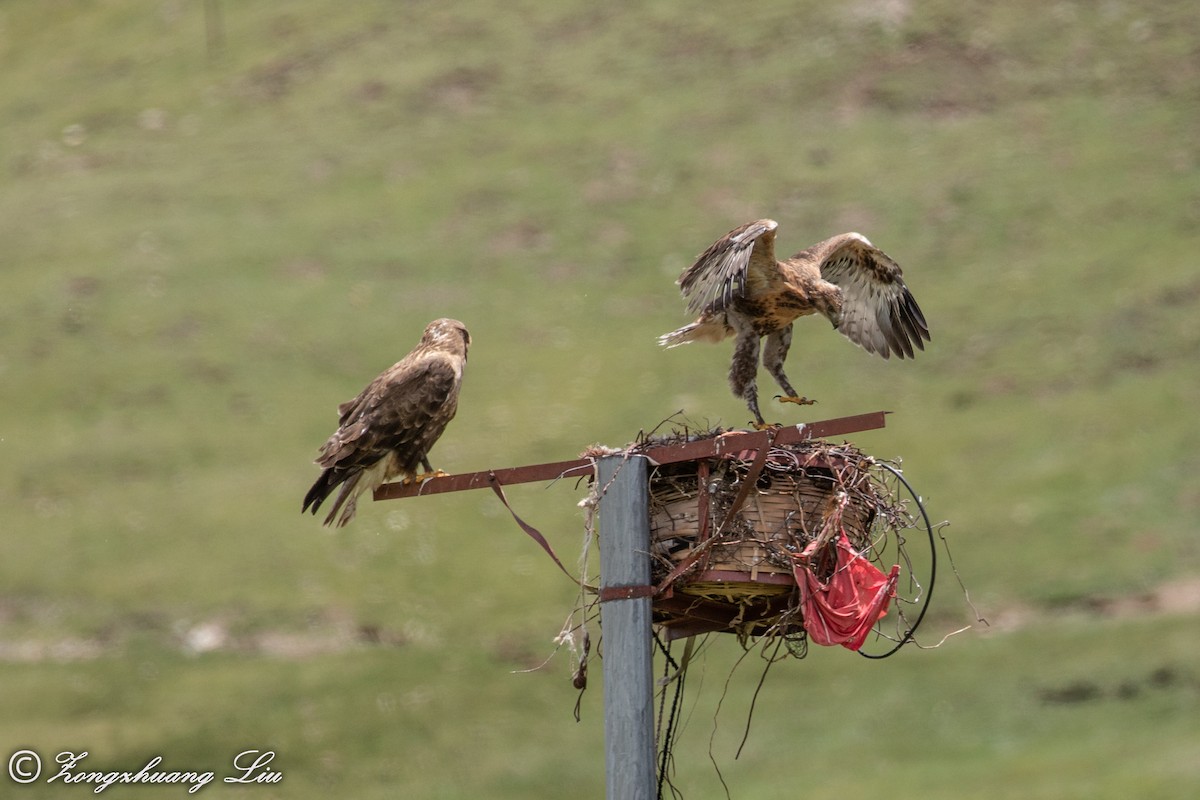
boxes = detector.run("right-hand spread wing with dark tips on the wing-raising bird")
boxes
[798,233,930,359]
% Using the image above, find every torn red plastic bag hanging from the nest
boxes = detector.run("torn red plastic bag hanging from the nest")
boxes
[793,530,900,650]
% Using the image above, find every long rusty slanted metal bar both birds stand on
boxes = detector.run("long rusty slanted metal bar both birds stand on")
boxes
[374,411,888,500]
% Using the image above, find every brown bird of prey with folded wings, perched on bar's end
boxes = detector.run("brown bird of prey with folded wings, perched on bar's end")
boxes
[301,319,470,527]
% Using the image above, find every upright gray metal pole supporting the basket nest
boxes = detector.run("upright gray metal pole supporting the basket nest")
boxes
[598,456,655,800]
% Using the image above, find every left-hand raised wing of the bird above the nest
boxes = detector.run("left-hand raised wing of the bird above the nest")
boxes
[679,219,779,314]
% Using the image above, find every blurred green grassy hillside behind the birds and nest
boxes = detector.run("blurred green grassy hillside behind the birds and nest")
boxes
[0,0,1200,799]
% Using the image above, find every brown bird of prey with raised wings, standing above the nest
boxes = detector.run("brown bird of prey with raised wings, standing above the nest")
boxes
[659,219,929,428]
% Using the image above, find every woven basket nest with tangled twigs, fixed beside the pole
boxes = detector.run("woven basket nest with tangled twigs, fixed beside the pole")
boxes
[633,433,895,638]
